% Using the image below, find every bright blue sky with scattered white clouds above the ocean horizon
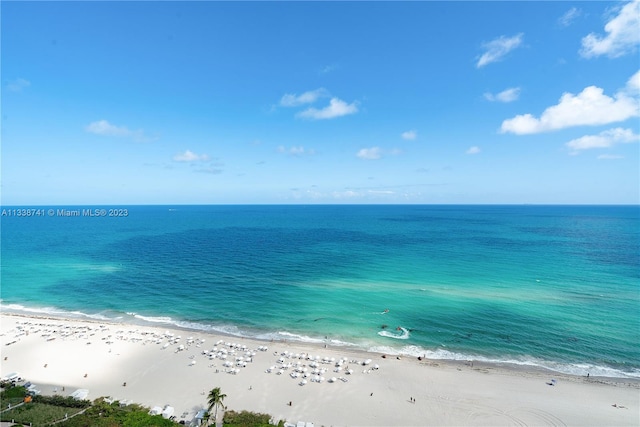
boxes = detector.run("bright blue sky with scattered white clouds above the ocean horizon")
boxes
[1,1,640,205]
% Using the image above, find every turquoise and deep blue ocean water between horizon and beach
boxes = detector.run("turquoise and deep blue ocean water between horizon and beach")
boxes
[0,205,640,377]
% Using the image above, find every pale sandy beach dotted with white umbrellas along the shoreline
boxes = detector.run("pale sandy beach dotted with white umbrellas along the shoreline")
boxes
[0,314,640,426]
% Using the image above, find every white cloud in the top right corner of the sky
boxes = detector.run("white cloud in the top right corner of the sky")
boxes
[580,0,640,58]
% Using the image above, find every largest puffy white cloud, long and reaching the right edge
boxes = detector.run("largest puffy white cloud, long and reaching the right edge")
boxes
[500,73,640,135]
